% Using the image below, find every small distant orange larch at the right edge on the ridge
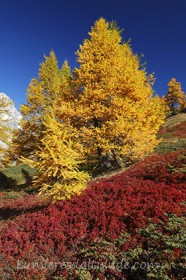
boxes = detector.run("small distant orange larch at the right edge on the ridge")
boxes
[165,78,186,114]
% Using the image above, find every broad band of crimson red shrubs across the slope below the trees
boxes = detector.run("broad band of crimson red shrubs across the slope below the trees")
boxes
[0,152,186,279]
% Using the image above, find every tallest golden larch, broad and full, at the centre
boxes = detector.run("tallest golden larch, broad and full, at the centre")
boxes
[72,18,165,171]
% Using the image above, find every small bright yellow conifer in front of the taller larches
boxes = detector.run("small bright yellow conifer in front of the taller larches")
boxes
[23,108,89,201]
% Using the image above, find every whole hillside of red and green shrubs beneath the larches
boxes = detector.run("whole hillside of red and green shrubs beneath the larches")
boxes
[0,114,186,280]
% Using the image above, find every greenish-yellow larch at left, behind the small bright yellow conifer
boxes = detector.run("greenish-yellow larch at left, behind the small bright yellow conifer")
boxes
[7,51,71,161]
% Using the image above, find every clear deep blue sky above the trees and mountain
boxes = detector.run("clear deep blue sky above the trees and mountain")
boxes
[0,0,186,108]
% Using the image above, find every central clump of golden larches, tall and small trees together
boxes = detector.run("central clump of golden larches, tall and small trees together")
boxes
[4,18,165,200]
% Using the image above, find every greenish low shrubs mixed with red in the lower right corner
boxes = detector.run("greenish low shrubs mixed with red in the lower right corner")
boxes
[64,215,186,280]
